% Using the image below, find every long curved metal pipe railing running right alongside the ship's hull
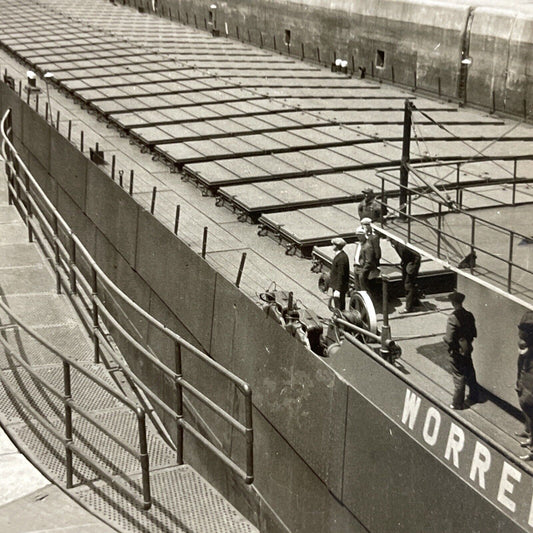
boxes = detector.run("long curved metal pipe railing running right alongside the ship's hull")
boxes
[0,110,253,483]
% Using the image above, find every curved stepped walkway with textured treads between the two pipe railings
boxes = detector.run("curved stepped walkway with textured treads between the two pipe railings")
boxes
[0,172,257,533]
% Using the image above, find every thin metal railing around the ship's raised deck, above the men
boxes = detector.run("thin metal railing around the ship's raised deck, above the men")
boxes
[372,162,533,294]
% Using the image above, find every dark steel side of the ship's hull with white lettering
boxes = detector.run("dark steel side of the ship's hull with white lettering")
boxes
[0,84,531,533]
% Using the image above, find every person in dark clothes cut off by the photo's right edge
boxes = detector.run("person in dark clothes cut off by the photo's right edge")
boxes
[516,312,533,461]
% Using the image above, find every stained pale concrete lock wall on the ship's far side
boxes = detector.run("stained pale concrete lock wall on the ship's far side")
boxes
[144,0,533,117]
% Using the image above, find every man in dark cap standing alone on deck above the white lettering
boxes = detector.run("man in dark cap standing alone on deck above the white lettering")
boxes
[444,291,479,409]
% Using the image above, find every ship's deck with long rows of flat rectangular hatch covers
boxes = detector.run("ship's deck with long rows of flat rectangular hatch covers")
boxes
[0,0,533,528]
